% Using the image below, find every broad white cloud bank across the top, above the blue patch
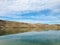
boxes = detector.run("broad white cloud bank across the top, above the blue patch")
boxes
[0,0,60,15]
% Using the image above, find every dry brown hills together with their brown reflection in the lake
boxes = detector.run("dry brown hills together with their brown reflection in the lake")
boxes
[0,20,60,35]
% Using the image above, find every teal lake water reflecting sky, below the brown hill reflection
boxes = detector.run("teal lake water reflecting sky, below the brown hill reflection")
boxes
[0,30,60,45]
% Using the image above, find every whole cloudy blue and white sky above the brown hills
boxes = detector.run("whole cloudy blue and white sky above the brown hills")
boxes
[0,0,60,24]
